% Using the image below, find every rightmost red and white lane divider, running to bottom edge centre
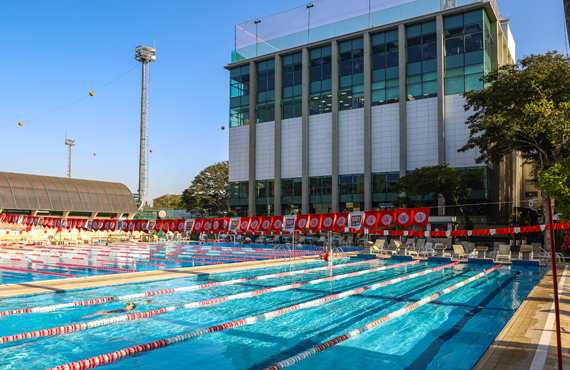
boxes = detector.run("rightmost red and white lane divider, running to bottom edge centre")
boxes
[264,265,502,370]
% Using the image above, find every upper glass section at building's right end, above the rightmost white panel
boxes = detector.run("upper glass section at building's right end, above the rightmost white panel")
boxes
[444,9,491,95]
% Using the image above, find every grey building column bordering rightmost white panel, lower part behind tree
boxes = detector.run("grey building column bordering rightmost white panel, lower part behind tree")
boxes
[435,14,445,216]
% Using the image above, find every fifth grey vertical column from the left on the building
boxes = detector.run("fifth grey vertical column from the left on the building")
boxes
[364,32,372,211]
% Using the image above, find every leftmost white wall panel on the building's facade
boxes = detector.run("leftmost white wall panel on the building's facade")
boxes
[229,126,249,182]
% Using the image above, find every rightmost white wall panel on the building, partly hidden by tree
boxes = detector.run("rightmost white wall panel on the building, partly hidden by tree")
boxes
[445,94,481,167]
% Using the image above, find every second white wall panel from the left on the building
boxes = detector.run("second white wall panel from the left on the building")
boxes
[255,122,275,180]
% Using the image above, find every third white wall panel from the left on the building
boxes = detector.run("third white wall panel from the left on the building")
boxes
[281,117,303,179]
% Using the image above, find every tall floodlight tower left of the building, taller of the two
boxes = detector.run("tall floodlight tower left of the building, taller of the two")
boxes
[135,45,156,204]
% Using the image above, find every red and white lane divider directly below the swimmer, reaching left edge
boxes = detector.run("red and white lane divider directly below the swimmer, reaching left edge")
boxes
[0,260,412,343]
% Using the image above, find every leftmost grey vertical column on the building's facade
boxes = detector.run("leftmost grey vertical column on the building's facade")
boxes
[248,61,257,216]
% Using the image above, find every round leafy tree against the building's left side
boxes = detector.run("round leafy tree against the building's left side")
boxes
[180,161,230,215]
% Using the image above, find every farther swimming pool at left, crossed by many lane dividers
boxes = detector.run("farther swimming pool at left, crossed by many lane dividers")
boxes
[0,243,342,284]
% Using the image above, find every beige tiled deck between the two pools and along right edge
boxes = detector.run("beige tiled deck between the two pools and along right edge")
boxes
[0,244,570,370]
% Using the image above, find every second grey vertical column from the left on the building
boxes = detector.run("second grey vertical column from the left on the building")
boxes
[273,54,283,216]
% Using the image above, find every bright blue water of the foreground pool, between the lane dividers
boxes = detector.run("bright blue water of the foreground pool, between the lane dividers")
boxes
[0,259,542,370]
